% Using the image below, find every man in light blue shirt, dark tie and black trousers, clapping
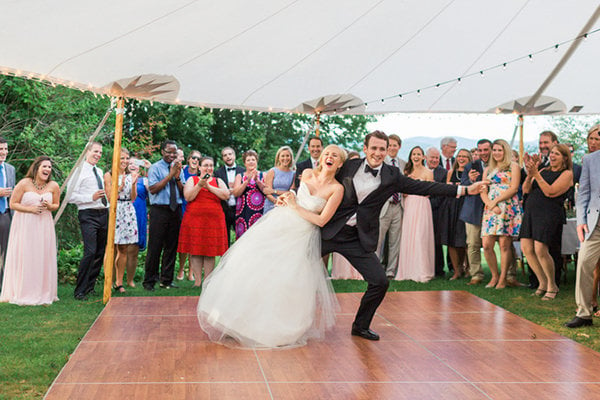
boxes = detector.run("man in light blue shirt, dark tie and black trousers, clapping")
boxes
[143,140,184,291]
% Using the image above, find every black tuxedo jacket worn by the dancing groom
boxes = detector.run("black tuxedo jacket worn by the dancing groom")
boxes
[321,159,457,252]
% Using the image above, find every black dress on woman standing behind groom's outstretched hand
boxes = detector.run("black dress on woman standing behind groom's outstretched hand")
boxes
[439,170,467,247]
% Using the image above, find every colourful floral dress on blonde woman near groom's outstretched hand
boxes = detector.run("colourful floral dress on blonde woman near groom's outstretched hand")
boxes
[481,170,523,237]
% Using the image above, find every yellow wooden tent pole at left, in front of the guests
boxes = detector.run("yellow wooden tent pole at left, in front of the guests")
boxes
[102,97,125,304]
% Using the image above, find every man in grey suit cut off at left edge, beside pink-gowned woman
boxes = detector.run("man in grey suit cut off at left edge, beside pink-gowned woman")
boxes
[0,137,15,287]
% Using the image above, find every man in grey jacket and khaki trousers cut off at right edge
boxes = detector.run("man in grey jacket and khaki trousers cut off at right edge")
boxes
[565,151,600,328]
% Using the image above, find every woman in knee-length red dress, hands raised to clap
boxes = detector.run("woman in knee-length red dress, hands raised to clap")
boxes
[177,157,230,287]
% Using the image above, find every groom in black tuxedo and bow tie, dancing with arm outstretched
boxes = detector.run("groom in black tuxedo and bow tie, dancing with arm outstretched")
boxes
[321,131,484,340]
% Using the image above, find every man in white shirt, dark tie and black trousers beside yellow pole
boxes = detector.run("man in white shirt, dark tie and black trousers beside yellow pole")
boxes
[69,142,108,300]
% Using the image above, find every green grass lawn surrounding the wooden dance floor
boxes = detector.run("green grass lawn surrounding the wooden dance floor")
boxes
[0,264,600,399]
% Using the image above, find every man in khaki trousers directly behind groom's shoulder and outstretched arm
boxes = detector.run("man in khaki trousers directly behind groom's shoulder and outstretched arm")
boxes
[377,134,406,279]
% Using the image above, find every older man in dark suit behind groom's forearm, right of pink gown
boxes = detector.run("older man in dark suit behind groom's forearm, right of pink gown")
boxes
[425,147,448,277]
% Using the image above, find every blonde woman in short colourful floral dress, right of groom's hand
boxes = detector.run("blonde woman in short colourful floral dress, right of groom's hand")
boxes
[481,139,523,289]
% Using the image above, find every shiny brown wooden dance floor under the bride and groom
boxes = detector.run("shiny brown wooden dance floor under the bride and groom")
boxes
[46,291,600,400]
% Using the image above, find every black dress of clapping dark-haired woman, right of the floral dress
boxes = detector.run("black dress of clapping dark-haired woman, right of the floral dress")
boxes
[519,169,567,247]
